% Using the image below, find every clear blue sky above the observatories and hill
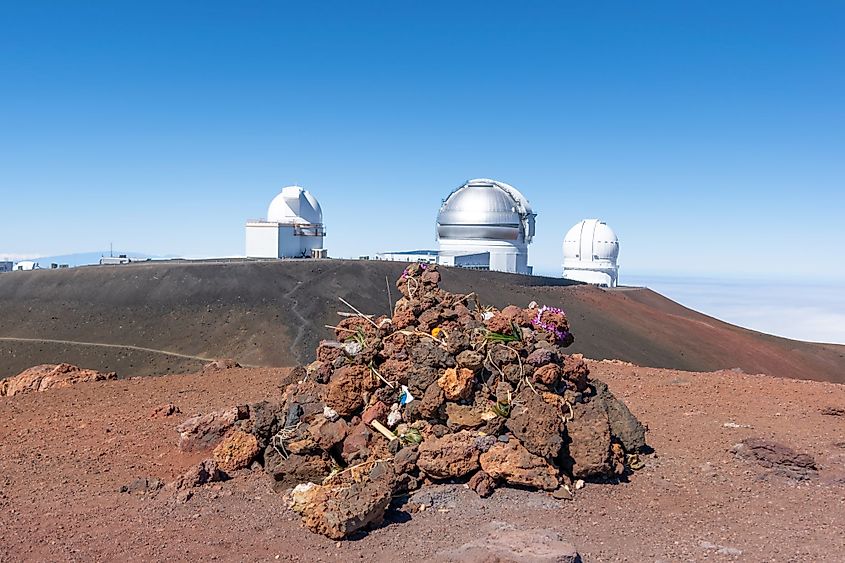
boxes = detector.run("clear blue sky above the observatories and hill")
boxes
[0,0,845,282]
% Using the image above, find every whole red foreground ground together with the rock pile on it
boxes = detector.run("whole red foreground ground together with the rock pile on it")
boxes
[0,270,845,561]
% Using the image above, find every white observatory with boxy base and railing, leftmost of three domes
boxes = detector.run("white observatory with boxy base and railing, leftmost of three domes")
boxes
[246,186,325,258]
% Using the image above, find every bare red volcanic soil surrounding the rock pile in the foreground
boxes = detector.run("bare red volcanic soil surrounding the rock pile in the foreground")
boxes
[0,362,845,561]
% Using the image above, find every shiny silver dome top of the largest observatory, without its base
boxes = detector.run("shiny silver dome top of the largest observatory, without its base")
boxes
[437,178,535,242]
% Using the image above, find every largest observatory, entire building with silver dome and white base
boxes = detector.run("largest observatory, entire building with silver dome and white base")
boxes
[437,178,536,274]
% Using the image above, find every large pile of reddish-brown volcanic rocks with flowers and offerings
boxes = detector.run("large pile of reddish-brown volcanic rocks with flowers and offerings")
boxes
[175,264,645,539]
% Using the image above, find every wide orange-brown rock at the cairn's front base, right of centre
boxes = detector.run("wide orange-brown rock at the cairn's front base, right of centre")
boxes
[479,440,559,491]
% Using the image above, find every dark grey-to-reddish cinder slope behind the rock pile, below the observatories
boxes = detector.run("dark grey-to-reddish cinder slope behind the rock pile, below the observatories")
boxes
[0,260,845,382]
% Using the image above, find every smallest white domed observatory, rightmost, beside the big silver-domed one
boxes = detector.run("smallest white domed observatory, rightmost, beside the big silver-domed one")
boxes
[563,219,619,287]
